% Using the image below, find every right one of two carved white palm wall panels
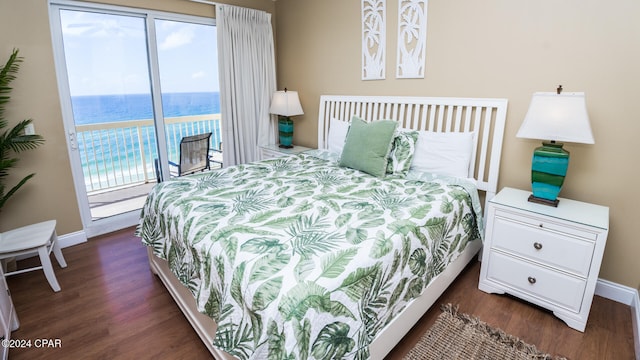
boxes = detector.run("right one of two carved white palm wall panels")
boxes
[396,0,427,78]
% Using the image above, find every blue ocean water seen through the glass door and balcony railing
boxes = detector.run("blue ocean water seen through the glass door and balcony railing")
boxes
[71,92,221,192]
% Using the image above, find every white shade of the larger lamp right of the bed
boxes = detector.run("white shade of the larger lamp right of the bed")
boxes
[516,92,594,144]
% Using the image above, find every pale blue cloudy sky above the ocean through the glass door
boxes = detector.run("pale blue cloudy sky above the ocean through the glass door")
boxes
[60,10,219,96]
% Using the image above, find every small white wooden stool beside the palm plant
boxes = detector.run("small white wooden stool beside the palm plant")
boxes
[0,220,67,292]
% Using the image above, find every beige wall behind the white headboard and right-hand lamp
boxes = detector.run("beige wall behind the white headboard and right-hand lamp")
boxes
[276,0,640,288]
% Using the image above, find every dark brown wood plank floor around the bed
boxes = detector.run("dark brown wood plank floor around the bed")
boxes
[3,229,634,360]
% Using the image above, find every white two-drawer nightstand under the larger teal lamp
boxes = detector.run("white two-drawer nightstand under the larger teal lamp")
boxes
[478,188,609,332]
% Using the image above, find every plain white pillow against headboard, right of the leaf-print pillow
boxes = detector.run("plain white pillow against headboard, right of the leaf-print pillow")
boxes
[411,131,475,178]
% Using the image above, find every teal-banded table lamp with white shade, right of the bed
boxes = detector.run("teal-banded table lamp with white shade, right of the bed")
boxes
[516,85,594,206]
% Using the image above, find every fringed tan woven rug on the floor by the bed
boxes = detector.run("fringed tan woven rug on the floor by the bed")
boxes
[404,304,566,360]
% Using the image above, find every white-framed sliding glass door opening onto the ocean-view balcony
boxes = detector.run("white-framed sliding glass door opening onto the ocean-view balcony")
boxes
[51,1,220,236]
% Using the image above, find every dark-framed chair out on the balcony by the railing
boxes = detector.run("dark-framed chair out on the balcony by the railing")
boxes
[169,132,211,176]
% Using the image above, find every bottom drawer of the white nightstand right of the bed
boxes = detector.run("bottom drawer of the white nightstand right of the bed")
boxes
[487,252,586,313]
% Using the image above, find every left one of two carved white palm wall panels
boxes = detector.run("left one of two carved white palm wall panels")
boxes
[362,0,387,80]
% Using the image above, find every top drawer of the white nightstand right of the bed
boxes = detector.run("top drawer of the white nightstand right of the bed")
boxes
[492,215,595,277]
